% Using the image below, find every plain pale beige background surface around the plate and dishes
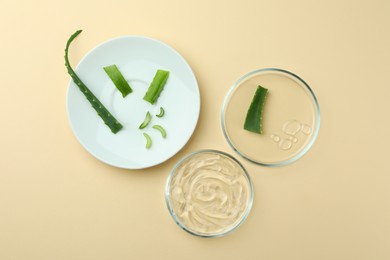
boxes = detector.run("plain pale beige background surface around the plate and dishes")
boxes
[0,0,390,260]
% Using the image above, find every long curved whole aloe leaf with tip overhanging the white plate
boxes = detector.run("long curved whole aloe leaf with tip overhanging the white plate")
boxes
[65,30,123,134]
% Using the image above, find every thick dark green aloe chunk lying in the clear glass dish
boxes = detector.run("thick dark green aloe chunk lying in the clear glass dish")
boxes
[244,85,268,134]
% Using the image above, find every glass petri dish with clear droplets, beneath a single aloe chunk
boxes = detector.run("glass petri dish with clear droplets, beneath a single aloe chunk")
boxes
[221,68,320,166]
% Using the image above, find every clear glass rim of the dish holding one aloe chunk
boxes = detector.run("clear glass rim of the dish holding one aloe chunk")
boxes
[221,68,321,167]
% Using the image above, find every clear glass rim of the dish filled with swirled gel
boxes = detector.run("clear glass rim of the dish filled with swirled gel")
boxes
[164,149,254,238]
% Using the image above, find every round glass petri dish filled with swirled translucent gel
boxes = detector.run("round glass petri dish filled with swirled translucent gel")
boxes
[165,150,253,237]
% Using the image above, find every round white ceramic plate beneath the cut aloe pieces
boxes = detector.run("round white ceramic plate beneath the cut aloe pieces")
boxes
[66,36,200,169]
